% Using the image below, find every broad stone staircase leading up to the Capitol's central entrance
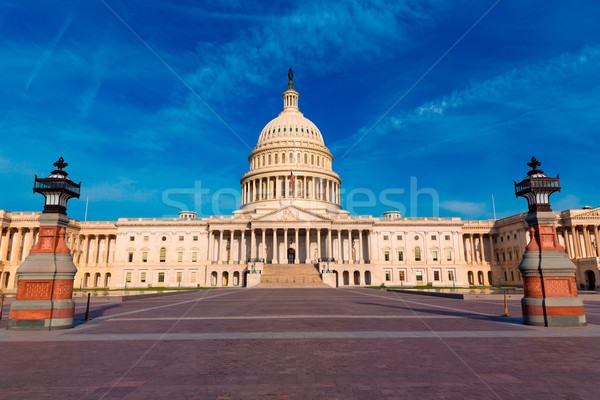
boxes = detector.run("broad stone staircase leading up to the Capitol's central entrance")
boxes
[255,264,329,288]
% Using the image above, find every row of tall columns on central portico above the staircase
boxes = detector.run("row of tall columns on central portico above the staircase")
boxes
[208,227,370,264]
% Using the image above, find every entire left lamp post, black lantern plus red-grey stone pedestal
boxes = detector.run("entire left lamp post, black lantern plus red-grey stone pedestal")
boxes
[8,157,81,330]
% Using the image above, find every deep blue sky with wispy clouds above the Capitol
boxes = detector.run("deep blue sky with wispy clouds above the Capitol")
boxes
[0,0,600,220]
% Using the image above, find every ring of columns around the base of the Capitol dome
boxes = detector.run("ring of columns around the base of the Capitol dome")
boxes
[242,175,341,204]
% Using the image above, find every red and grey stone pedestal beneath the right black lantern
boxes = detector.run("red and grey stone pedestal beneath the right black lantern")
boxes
[519,212,586,326]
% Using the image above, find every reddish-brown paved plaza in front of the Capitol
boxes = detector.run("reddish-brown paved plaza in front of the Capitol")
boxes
[0,288,600,400]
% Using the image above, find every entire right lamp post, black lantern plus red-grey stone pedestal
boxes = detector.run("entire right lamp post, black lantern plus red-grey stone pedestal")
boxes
[515,157,586,326]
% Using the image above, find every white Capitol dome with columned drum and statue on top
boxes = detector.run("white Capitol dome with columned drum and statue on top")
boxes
[236,69,347,219]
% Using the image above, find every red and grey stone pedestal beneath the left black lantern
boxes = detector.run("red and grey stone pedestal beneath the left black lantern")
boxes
[8,213,77,330]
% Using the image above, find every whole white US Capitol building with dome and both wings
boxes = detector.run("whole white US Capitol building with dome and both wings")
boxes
[0,70,600,291]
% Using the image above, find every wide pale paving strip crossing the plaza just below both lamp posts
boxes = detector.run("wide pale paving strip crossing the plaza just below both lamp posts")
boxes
[0,325,600,343]
